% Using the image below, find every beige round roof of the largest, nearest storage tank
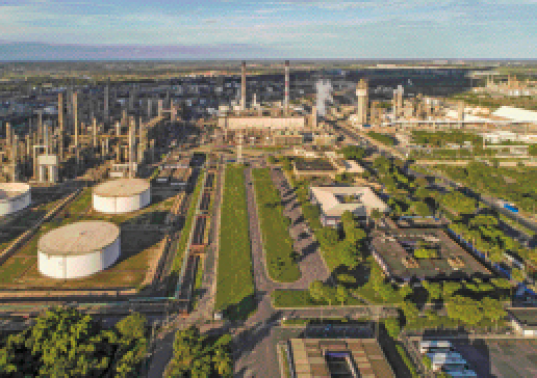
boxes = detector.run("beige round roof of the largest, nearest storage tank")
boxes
[38,221,120,256]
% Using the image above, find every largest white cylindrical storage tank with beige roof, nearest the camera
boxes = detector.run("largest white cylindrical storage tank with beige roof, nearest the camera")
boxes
[37,221,121,279]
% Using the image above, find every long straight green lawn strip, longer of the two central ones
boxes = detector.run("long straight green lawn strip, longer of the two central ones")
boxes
[215,165,255,320]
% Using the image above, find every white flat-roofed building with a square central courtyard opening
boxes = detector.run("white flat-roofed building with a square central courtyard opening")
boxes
[310,186,390,226]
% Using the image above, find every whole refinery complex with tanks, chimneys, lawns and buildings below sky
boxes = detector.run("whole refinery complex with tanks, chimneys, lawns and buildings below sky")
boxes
[0,59,537,378]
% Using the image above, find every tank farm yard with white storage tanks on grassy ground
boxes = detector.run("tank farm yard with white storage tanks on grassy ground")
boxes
[0,151,221,313]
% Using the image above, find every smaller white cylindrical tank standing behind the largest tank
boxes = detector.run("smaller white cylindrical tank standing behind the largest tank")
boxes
[93,179,151,214]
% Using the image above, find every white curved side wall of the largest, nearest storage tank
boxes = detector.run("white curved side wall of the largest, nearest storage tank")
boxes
[37,237,121,279]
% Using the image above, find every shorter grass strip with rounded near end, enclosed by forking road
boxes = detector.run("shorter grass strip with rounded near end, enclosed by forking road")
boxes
[253,168,301,282]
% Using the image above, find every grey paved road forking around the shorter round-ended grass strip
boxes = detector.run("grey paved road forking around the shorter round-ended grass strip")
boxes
[235,168,330,378]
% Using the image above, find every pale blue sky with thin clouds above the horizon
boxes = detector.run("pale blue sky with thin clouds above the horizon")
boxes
[0,0,537,60]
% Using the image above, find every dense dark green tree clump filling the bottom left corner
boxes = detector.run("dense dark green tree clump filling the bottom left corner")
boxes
[0,307,148,377]
